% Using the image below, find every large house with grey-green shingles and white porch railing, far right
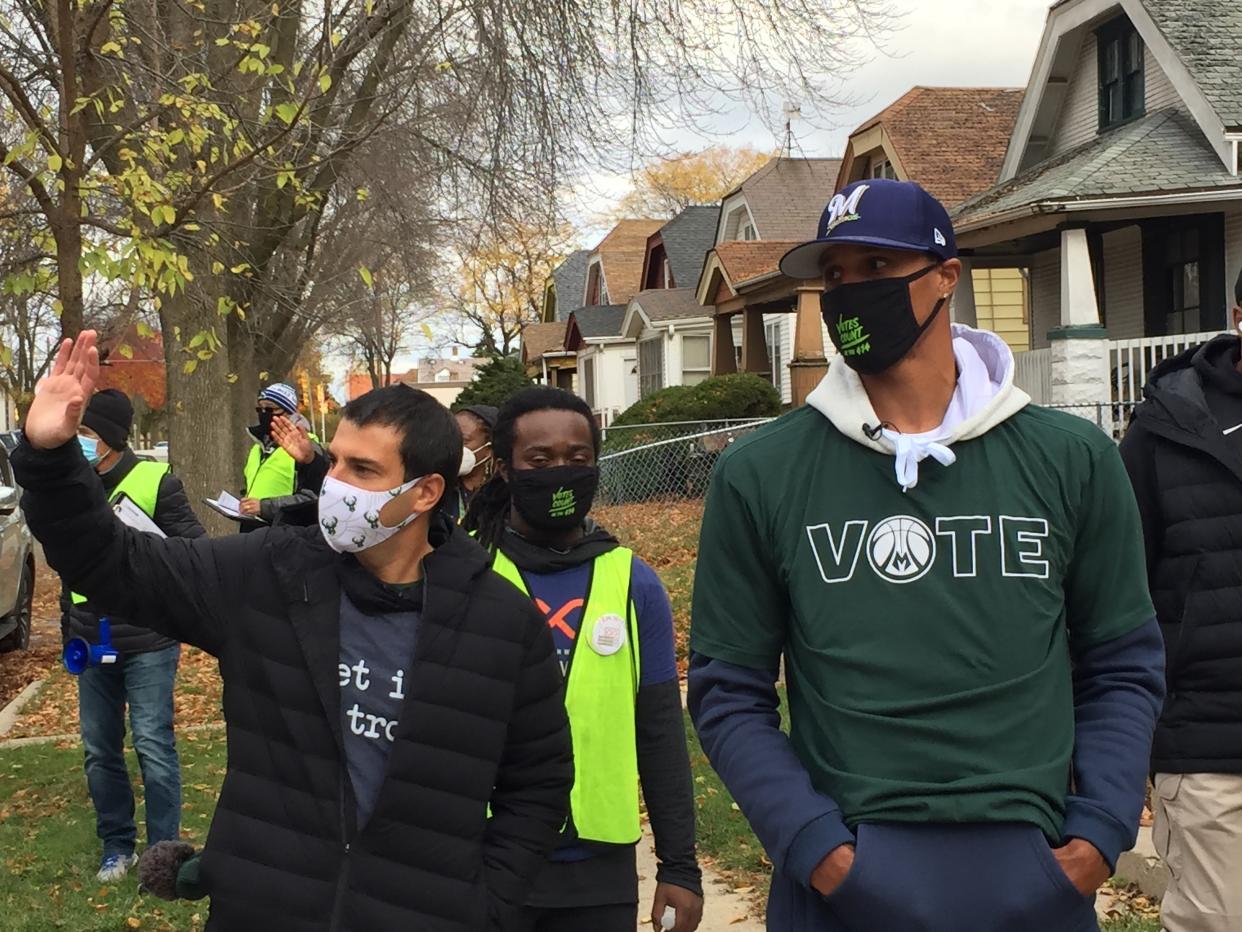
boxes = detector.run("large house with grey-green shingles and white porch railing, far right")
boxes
[954,0,1242,420]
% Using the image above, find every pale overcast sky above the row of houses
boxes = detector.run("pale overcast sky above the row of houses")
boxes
[365,0,1051,385]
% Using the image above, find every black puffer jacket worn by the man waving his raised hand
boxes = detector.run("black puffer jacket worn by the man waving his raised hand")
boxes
[12,442,573,932]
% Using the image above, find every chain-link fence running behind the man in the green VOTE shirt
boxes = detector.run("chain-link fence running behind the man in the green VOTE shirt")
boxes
[599,403,1134,505]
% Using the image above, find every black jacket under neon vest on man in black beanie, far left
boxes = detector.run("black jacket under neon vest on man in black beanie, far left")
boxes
[61,447,207,655]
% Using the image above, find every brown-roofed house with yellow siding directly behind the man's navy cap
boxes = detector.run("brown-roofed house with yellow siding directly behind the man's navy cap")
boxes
[837,87,1031,352]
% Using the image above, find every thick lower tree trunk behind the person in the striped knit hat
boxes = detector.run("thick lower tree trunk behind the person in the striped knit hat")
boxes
[160,284,242,536]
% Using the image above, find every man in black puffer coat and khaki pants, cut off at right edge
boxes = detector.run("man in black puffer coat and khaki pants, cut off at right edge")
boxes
[1122,265,1242,932]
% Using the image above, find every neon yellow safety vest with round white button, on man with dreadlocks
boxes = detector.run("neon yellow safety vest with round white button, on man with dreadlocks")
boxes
[492,547,642,845]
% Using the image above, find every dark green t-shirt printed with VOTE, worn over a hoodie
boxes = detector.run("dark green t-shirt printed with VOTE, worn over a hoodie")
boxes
[691,406,1154,839]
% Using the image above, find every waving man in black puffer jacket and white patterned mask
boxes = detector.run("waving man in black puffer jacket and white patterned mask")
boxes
[12,332,573,932]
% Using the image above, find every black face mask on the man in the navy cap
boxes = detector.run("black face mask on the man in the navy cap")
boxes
[820,262,948,375]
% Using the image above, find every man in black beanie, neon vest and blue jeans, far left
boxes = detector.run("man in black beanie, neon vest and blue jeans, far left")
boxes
[61,389,206,884]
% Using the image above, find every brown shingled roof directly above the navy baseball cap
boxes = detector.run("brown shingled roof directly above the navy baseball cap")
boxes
[838,87,1025,208]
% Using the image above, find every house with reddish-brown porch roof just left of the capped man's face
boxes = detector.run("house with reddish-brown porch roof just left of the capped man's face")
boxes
[696,157,841,404]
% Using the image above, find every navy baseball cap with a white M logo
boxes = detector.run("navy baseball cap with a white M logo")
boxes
[780,178,958,278]
